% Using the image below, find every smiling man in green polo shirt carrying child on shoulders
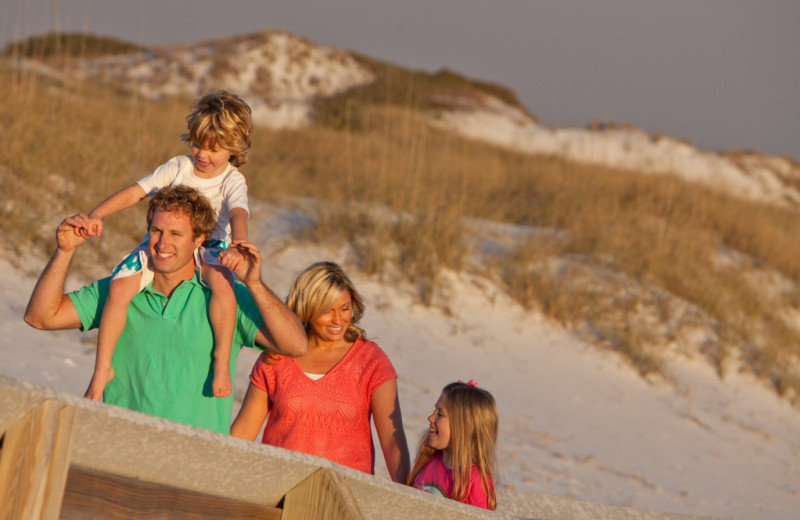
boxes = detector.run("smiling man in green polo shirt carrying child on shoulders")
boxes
[25,186,308,434]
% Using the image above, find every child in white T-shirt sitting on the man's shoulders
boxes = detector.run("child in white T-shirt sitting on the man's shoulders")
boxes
[82,91,252,401]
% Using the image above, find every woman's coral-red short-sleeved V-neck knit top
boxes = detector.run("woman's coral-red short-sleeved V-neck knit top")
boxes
[250,338,397,473]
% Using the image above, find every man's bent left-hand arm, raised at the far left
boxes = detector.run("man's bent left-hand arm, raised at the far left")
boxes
[25,213,89,330]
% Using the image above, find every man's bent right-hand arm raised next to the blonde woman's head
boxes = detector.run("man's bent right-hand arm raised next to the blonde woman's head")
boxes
[231,240,308,357]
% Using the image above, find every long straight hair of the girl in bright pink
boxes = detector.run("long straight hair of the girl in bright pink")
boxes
[408,381,498,510]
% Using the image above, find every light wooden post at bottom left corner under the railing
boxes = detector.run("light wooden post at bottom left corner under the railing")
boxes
[0,400,75,520]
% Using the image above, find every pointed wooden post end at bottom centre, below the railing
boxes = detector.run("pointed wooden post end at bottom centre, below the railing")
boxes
[281,468,364,520]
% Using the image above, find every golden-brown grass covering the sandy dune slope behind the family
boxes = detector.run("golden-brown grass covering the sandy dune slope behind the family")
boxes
[0,44,800,400]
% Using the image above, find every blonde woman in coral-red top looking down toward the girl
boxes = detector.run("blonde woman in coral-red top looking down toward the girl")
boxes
[231,262,409,483]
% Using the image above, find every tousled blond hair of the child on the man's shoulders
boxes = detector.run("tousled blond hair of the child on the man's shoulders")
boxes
[181,90,253,168]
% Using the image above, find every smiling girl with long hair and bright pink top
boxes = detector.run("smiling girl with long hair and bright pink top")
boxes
[408,380,497,510]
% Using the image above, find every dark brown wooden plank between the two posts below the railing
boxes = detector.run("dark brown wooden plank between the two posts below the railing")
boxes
[60,466,281,520]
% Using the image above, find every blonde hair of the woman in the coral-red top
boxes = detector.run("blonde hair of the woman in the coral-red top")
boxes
[286,262,365,341]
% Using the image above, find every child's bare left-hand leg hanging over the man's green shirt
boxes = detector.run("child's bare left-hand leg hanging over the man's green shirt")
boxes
[84,273,142,401]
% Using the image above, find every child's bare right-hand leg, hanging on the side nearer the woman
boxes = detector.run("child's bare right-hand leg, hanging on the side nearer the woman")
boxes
[201,262,236,397]
